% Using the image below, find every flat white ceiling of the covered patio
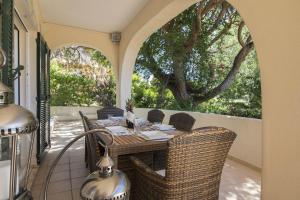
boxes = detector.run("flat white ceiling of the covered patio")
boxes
[39,0,149,33]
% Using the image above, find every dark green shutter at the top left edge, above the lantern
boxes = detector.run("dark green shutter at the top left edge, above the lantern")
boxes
[1,0,14,88]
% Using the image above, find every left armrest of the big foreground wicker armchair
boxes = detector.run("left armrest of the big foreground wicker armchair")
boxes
[130,156,166,185]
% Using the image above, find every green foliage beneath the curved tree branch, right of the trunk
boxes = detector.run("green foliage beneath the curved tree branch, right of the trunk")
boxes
[196,52,262,118]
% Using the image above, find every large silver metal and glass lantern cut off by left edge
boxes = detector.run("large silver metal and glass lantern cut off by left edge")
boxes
[0,51,38,200]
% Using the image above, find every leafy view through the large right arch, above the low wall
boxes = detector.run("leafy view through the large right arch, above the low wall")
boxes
[133,1,261,118]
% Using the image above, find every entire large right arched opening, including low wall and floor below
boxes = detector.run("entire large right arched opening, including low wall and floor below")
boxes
[131,0,262,199]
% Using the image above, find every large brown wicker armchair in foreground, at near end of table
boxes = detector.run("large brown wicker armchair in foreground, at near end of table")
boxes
[131,127,236,200]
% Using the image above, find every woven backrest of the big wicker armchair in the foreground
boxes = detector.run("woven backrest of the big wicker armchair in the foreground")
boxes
[166,127,236,199]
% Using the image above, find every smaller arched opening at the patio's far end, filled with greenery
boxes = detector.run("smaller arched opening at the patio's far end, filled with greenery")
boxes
[50,45,116,119]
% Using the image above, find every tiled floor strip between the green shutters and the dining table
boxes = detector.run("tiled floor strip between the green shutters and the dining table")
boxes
[31,121,88,200]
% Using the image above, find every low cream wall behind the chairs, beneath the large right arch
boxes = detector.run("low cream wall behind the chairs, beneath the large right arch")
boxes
[134,108,262,169]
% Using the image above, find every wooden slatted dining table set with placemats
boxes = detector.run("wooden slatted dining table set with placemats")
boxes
[91,120,184,171]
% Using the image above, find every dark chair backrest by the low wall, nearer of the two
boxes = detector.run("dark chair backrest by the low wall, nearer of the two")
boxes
[169,112,196,131]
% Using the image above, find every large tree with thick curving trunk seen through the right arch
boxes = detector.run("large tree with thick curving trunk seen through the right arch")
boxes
[136,0,254,108]
